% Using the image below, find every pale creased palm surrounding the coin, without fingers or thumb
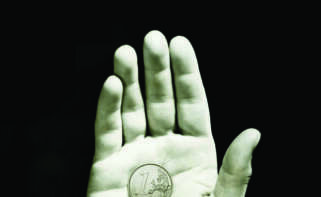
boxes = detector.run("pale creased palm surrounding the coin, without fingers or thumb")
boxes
[89,134,217,197]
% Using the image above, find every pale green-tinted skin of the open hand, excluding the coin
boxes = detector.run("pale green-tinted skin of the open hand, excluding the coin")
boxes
[88,31,260,197]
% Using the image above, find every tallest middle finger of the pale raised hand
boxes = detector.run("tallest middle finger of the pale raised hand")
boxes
[144,31,175,135]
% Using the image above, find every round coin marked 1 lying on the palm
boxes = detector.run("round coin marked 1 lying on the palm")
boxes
[128,164,173,197]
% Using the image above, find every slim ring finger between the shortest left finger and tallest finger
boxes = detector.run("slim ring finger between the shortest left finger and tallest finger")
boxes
[114,45,146,143]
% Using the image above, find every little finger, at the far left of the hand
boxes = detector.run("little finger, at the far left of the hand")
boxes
[95,76,123,160]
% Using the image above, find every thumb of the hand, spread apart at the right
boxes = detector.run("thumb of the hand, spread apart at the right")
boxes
[214,129,260,197]
